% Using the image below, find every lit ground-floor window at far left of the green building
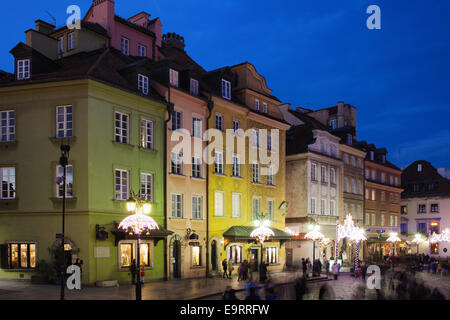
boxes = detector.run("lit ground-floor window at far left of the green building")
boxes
[7,243,36,269]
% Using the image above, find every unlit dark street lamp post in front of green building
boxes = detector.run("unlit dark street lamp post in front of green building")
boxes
[56,144,70,300]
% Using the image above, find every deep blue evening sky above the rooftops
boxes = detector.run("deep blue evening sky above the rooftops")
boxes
[0,0,450,168]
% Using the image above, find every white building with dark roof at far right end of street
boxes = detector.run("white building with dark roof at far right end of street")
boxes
[400,160,450,257]
